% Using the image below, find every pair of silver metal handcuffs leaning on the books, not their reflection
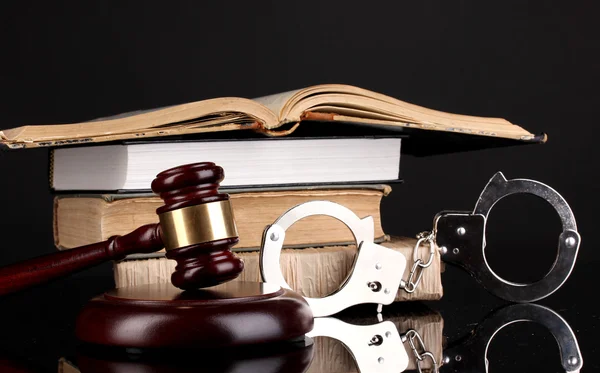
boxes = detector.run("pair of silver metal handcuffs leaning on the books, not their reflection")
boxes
[260,172,581,317]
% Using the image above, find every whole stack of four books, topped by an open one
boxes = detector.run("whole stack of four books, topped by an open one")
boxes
[0,85,546,300]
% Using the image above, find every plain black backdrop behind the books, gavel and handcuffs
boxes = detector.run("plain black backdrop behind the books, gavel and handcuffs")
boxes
[0,1,600,372]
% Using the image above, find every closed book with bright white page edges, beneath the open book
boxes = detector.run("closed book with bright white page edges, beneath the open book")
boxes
[49,136,401,192]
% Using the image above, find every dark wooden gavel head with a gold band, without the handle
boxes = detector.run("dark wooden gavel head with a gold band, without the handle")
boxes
[152,162,244,290]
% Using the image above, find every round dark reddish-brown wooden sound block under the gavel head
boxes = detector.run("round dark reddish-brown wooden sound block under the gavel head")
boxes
[75,281,313,348]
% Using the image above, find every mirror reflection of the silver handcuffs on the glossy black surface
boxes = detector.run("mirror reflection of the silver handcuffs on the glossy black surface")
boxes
[308,304,583,373]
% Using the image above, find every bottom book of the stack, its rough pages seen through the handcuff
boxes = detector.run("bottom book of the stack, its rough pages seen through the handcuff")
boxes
[114,237,443,301]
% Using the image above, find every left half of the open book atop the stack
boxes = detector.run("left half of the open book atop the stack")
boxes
[0,97,278,148]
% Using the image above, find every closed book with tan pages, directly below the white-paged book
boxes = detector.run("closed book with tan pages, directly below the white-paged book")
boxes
[54,184,391,251]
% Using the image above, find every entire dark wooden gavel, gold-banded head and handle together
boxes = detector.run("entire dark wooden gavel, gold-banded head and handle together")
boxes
[0,162,244,295]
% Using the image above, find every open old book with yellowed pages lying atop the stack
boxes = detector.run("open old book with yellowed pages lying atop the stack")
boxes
[0,84,546,149]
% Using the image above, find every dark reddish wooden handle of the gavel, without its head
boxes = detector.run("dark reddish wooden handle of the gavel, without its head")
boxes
[0,224,164,296]
